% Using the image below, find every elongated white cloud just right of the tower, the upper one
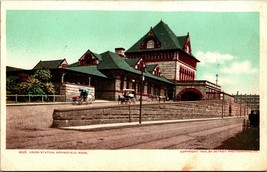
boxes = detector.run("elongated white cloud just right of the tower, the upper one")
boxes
[195,51,235,65]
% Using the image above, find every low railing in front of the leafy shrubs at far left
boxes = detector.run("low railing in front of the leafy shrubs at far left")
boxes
[6,94,66,104]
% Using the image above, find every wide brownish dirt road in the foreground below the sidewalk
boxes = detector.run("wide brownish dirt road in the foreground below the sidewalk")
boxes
[7,115,243,149]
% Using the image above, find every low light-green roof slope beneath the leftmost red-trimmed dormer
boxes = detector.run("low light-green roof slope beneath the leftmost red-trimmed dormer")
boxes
[64,65,107,78]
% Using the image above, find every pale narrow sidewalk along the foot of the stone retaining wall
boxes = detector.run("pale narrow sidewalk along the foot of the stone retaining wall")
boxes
[59,117,243,131]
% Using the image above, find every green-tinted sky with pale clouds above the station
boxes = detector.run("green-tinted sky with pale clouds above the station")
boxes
[6,10,260,94]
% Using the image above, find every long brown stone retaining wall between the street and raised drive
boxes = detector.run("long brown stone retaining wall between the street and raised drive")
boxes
[52,101,250,127]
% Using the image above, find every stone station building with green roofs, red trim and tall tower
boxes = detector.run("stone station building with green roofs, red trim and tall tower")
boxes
[7,21,228,101]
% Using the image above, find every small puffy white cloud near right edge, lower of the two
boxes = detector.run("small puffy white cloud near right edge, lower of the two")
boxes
[221,60,258,74]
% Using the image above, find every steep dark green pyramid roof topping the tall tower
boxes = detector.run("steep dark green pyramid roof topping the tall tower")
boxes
[126,21,182,53]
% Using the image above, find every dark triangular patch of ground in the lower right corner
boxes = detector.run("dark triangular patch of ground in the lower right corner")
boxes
[215,127,260,150]
